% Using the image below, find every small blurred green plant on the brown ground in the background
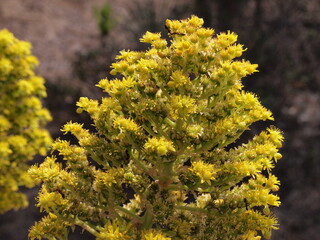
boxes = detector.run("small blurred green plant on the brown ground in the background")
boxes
[93,3,115,36]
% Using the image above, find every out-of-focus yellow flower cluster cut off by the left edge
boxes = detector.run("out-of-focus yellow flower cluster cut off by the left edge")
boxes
[0,29,51,213]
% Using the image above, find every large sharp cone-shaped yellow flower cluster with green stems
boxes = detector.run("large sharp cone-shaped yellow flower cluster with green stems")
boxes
[29,16,283,240]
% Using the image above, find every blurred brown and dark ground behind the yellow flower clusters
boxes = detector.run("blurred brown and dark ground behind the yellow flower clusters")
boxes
[0,0,320,240]
